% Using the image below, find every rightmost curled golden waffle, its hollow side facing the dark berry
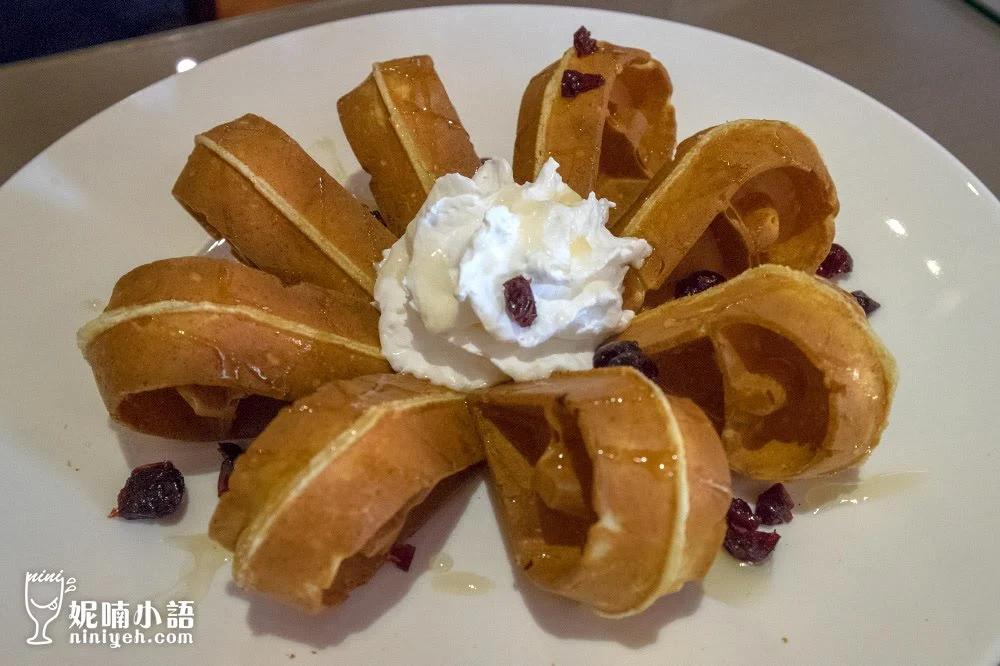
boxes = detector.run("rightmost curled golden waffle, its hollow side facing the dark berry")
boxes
[617,265,897,481]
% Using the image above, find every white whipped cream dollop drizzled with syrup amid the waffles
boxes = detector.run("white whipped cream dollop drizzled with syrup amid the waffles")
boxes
[375,159,651,390]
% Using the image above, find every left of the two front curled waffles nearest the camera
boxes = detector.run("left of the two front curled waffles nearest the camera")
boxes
[209,375,483,612]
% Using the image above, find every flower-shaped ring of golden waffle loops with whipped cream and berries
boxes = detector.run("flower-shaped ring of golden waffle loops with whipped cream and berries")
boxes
[78,28,896,617]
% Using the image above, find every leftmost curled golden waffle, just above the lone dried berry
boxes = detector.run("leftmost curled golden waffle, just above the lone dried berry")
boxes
[77,257,389,440]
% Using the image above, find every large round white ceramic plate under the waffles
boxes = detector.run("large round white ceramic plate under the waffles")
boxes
[0,7,1000,664]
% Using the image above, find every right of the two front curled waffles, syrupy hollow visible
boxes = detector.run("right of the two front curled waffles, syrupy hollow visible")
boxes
[469,368,731,617]
